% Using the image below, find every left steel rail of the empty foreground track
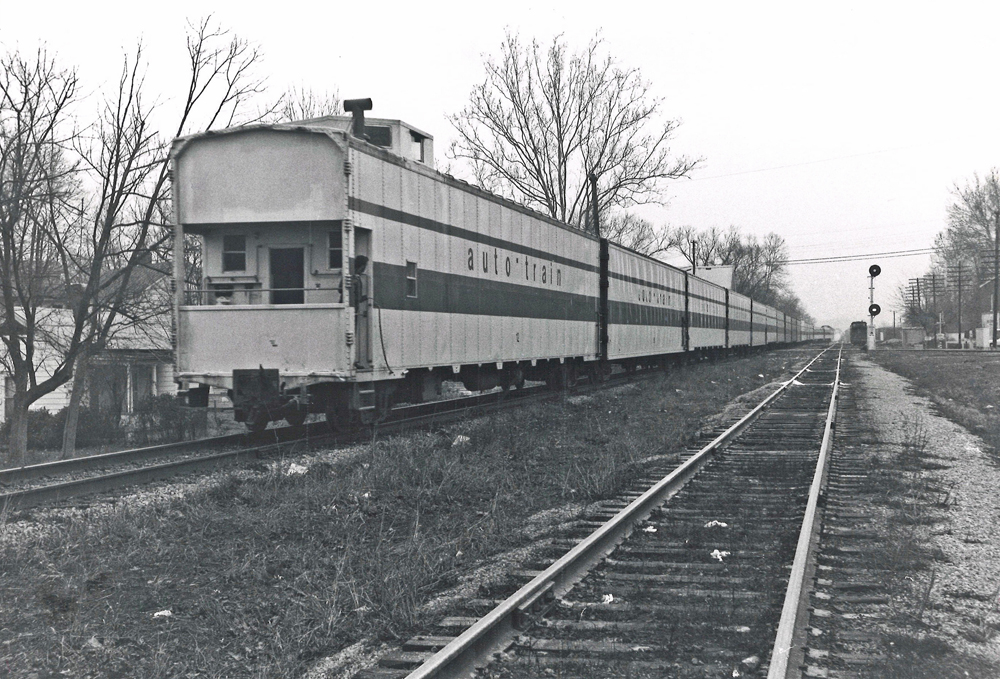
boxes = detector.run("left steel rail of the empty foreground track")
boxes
[407,347,829,679]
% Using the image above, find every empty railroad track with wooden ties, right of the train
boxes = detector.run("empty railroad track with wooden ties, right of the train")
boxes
[357,350,840,679]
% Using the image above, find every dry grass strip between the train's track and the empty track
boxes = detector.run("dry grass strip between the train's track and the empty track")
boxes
[0,354,804,678]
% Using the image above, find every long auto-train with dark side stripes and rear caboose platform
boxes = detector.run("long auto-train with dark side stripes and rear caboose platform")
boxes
[171,100,814,430]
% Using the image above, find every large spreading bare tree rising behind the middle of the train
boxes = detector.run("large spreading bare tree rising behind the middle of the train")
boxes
[449,33,699,232]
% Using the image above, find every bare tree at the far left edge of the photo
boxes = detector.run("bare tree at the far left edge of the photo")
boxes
[0,50,77,462]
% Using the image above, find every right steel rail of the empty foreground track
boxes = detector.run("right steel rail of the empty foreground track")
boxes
[767,348,843,679]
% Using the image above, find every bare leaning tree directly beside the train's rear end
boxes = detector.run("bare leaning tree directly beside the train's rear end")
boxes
[60,18,274,457]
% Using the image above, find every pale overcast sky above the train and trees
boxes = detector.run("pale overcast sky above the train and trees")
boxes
[0,0,1000,328]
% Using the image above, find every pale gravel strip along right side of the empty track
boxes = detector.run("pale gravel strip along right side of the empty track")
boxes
[852,358,1000,662]
